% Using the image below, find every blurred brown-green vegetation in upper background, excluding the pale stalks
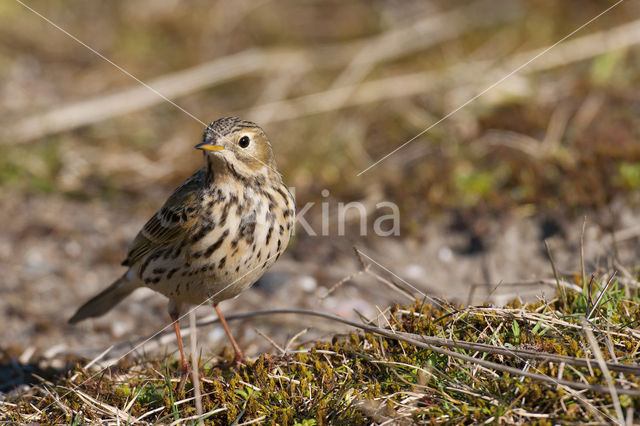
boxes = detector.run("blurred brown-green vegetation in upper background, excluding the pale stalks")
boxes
[0,0,640,233]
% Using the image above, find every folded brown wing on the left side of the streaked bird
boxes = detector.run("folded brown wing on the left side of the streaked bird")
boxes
[122,170,204,266]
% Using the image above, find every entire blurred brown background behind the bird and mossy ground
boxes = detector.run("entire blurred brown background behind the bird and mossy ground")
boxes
[0,0,640,378]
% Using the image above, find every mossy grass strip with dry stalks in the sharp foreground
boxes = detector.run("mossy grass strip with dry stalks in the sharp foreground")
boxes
[0,275,640,425]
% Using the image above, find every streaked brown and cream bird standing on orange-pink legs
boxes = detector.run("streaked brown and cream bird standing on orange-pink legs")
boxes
[69,117,295,375]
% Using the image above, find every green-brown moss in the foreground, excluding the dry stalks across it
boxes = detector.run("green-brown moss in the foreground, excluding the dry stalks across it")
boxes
[6,279,640,425]
